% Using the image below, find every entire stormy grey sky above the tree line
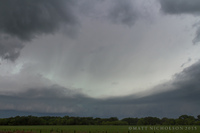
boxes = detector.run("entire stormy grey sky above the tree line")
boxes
[0,0,200,118]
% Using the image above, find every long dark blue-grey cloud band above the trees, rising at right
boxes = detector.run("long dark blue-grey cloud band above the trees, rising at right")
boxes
[0,61,200,118]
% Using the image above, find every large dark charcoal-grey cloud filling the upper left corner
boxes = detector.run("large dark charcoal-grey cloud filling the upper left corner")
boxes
[0,0,77,60]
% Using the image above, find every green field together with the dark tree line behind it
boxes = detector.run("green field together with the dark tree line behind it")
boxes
[0,115,200,133]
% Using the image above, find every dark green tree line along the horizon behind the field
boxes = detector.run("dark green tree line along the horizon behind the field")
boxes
[0,115,200,125]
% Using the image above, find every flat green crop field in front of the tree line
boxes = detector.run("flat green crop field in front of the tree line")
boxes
[0,125,200,133]
